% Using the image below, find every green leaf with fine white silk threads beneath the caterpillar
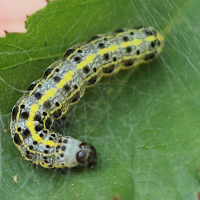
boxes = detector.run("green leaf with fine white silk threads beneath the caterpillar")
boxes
[0,0,200,200]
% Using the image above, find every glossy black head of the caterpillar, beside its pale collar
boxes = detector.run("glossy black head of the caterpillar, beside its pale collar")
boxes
[76,142,97,167]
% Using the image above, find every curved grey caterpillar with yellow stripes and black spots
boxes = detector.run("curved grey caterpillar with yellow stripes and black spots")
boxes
[10,26,164,169]
